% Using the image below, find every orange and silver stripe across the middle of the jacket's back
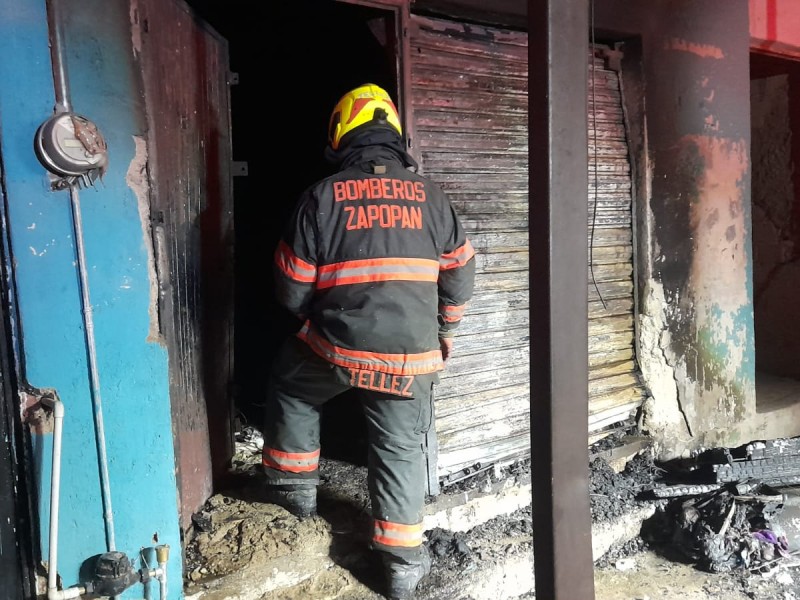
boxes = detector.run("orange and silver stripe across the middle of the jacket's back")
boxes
[317,258,439,289]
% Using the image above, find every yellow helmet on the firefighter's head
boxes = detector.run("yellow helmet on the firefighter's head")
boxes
[328,83,403,150]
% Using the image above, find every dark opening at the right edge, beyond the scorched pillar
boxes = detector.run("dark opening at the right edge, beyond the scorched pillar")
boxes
[750,53,800,410]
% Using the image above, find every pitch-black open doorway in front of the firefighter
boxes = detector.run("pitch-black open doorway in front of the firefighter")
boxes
[189,0,398,458]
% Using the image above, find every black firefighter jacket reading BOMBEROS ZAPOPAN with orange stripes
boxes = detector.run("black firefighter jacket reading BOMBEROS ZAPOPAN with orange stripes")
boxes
[275,136,475,395]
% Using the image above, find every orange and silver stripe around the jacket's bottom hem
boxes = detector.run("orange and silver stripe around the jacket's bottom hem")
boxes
[297,321,444,375]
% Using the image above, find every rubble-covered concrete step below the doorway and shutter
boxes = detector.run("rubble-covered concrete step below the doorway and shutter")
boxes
[185,464,655,600]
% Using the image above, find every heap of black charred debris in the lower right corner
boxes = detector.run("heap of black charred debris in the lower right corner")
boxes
[641,438,800,573]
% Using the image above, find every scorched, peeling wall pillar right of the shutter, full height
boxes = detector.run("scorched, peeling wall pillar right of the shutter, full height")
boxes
[596,0,755,455]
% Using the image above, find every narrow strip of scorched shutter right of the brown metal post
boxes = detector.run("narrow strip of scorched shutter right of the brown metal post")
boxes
[588,46,646,433]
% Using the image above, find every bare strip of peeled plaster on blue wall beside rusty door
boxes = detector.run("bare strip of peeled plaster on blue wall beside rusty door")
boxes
[125,136,164,344]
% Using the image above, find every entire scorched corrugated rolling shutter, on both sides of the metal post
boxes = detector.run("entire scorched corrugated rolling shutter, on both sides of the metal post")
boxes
[410,15,643,478]
